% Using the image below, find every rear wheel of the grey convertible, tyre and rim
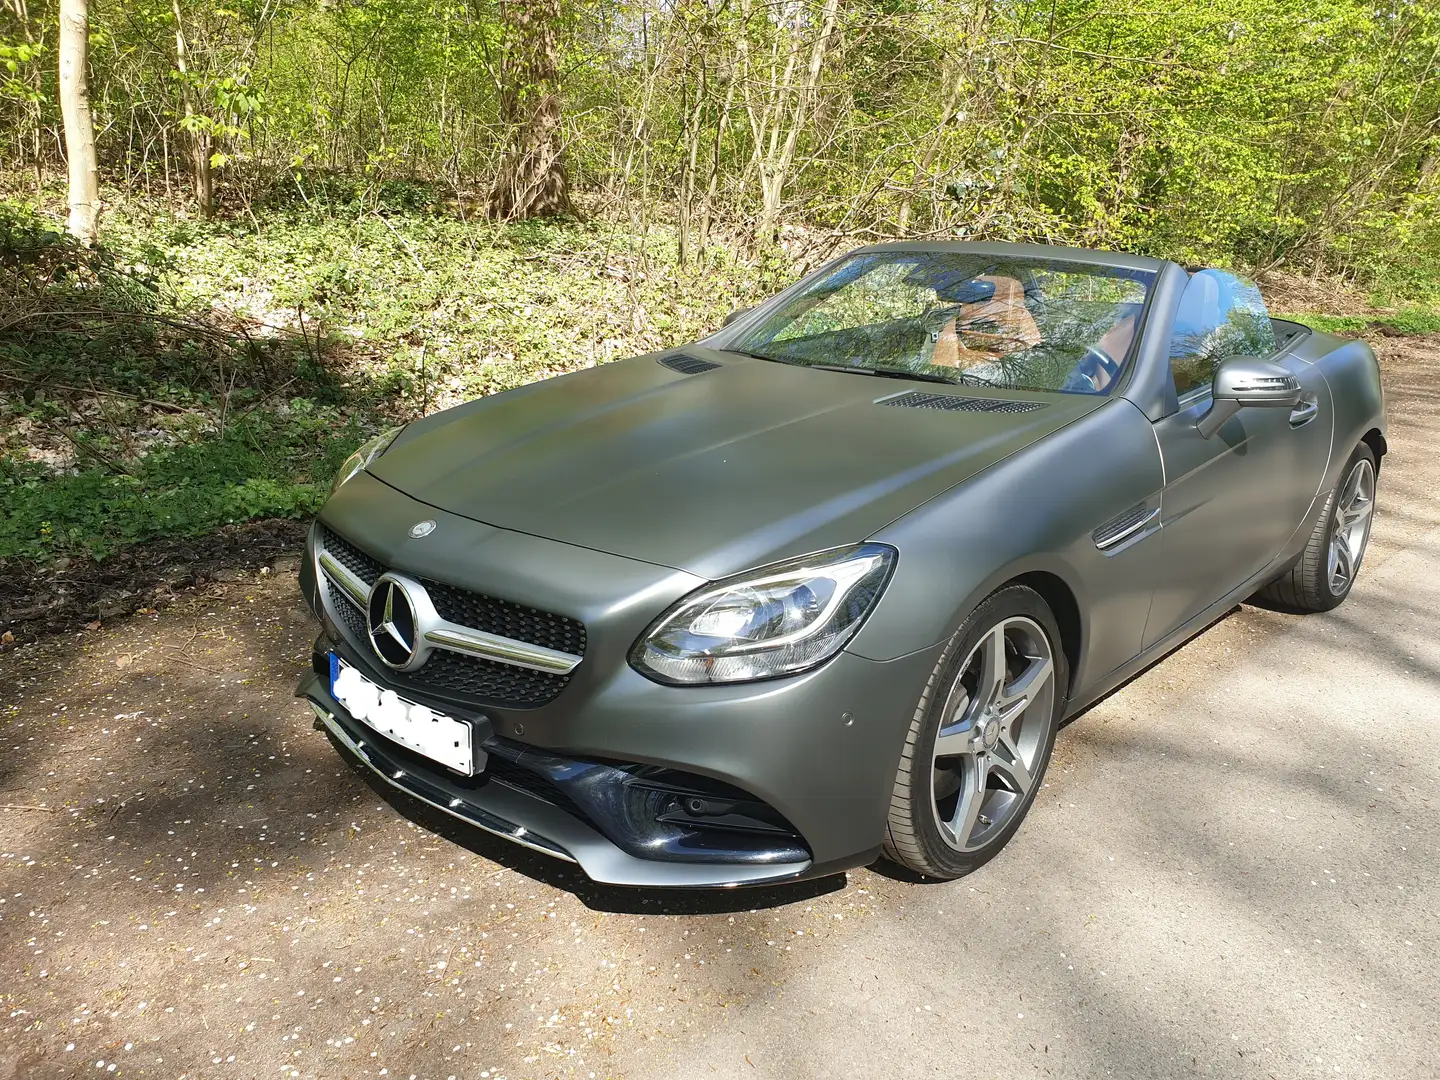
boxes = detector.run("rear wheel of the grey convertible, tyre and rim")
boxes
[1257,442,1377,615]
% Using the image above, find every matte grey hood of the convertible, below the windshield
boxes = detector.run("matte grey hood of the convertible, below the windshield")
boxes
[370,347,1106,579]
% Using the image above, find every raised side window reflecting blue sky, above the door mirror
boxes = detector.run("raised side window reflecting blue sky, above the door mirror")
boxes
[1169,269,1279,397]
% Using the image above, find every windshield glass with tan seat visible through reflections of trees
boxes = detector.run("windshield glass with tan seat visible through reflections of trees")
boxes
[729,251,1155,393]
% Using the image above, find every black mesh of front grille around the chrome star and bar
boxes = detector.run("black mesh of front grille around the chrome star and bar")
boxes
[320,527,586,708]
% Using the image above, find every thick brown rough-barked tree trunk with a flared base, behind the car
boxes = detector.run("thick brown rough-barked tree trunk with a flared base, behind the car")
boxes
[490,0,573,219]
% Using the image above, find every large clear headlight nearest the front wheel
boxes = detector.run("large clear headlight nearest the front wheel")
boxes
[631,544,896,685]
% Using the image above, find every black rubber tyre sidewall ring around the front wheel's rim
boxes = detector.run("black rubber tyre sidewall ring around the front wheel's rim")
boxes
[907,585,1070,877]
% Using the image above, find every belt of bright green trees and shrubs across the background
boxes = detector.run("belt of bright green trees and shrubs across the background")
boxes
[0,0,1440,305]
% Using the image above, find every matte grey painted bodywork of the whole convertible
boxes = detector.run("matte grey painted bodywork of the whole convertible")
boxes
[302,245,1384,884]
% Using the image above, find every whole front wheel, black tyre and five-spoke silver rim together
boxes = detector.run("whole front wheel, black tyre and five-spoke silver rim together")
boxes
[884,585,1070,878]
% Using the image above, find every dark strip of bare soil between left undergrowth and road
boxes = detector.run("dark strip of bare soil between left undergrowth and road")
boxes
[0,518,307,651]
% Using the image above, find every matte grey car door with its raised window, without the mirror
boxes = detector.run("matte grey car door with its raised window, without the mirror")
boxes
[1145,269,1333,647]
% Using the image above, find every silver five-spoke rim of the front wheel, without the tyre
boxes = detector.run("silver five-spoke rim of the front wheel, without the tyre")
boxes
[932,616,1056,851]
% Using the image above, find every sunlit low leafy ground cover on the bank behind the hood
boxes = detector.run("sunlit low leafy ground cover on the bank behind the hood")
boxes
[77,194,771,412]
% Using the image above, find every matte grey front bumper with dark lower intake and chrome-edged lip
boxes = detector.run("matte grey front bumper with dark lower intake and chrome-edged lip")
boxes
[295,638,933,888]
